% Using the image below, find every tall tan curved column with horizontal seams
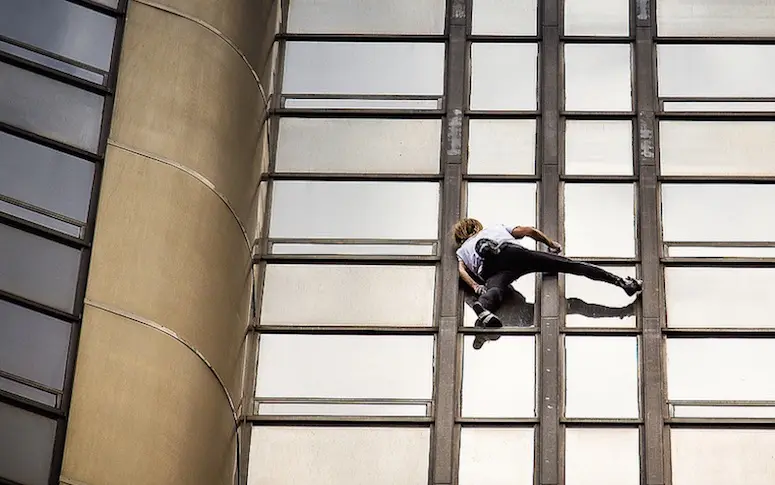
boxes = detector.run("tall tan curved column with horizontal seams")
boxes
[61,0,275,485]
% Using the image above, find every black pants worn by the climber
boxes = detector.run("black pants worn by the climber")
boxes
[479,244,622,312]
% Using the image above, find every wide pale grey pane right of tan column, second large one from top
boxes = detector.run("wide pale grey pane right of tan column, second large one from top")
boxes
[282,42,444,95]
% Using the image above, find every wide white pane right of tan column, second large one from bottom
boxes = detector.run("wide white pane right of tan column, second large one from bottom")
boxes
[256,334,434,400]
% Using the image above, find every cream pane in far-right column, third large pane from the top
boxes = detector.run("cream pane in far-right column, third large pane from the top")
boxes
[659,121,775,176]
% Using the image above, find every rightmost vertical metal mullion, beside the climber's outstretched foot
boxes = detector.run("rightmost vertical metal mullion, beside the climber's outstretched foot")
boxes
[635,0,665,485]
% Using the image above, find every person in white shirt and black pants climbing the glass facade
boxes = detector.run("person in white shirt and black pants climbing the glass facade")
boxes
[453,218,642,328]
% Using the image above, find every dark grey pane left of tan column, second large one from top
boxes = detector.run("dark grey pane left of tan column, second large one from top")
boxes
[0,63,104,152]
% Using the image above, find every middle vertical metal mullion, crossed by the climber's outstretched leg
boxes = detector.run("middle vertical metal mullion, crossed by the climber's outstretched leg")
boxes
[537,0,562,485]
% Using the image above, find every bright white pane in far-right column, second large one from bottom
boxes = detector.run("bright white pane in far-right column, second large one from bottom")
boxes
[666,338,775,401]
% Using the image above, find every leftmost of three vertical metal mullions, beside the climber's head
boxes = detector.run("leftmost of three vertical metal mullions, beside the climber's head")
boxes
[431,0,468,485]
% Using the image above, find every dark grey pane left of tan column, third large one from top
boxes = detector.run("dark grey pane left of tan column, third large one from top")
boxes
[0,132,94,223]
